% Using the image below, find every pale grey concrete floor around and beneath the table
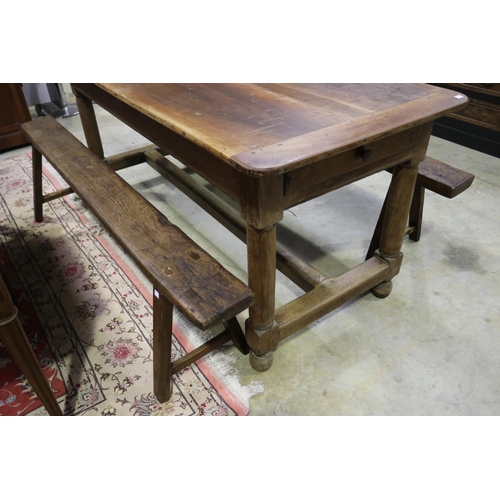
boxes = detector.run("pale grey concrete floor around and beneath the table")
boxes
[0,86,500,415]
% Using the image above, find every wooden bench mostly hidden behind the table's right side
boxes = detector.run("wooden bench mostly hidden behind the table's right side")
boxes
[366,156,474,259]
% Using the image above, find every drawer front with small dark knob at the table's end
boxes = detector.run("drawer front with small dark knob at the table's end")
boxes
[285,129,417,207]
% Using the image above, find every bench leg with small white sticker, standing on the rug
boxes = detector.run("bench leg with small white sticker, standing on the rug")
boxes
[153,288,174,403]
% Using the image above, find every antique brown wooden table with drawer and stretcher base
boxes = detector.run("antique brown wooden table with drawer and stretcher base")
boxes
[69,84,467,371]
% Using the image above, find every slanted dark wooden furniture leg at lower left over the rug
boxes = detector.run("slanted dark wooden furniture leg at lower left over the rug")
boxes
[0,274,62,416]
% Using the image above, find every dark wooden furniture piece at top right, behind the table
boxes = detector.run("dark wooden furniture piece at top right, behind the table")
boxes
[432,83,500,158]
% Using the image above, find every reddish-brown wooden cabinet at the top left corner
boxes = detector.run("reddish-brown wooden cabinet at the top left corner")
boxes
[0,83,31,151]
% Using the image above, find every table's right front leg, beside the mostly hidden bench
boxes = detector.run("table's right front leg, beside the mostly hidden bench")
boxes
[372,164,418,298]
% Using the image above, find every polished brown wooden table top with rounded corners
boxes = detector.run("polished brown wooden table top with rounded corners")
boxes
[97,83,468,176]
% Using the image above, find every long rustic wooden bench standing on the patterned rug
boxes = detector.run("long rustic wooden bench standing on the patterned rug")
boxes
[22,117,253,402]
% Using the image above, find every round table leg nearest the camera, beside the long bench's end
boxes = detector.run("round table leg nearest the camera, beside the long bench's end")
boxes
[246,225,279,372]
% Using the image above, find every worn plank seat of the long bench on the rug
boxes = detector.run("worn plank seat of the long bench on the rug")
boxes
[24,117,253,329]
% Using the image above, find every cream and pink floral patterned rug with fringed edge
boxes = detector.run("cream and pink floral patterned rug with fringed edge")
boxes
[0,154,263,416]
